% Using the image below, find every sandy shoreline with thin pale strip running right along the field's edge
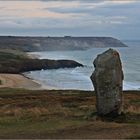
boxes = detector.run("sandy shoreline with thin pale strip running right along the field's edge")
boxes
[0,73,140,92]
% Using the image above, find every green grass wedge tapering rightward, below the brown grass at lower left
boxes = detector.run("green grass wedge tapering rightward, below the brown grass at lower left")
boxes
[0,117,86,137]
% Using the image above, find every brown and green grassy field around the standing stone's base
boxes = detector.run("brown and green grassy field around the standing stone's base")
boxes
[0,88,140,139]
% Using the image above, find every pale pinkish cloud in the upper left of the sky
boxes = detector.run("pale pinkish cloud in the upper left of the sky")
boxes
[0,1,75,18]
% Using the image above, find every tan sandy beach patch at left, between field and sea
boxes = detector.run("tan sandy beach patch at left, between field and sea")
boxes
[0,74,41,90]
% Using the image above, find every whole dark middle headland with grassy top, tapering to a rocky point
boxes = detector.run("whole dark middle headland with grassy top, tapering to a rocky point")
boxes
[0,52,83,73]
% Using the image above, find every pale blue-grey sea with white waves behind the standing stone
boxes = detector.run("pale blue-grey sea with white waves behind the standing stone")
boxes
[25,41,140,90]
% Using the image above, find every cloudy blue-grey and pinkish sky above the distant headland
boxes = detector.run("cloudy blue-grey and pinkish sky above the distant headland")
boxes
[0,0,140,40]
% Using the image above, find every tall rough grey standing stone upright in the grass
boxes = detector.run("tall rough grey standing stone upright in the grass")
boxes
[91,49,123,116]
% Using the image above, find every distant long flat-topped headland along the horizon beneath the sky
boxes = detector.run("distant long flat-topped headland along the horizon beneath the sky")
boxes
[0,36,126,52]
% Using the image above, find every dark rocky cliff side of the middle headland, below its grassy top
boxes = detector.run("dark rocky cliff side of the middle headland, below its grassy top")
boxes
[0,59,83,74]
